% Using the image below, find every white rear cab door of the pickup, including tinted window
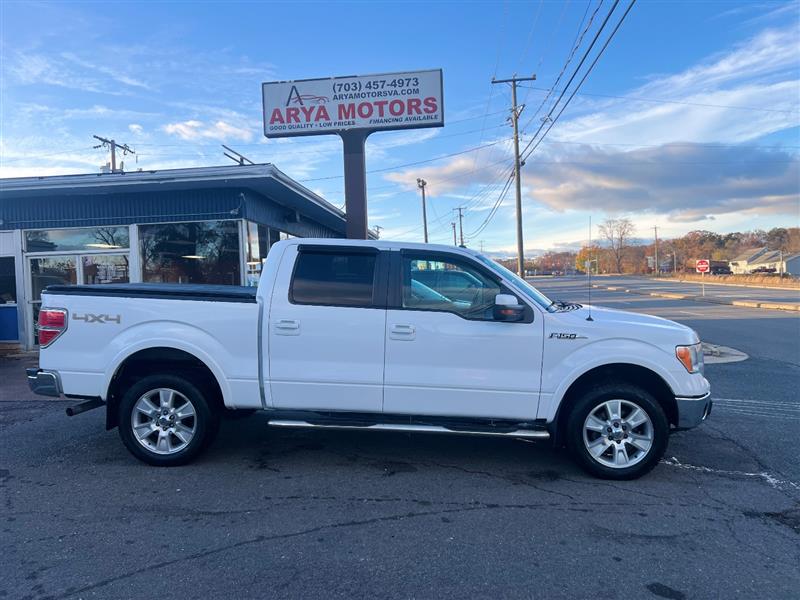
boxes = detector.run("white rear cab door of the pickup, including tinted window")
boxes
[268,244,388,412]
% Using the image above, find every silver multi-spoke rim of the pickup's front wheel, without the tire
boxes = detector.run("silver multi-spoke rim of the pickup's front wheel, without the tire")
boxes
[583,400,654,469]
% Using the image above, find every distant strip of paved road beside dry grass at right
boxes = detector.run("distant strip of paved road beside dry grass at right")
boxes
[580,275,800,303]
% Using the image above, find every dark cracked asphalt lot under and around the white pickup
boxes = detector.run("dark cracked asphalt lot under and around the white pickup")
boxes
[0,278,800,600]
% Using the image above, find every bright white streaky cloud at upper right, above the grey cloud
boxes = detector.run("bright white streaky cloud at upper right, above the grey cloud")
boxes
[556,27,800,144]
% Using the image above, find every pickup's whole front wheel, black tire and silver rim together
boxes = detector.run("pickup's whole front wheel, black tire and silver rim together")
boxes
[566,383,669,480]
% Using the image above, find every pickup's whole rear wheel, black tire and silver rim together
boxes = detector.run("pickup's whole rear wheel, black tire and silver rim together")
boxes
[119,374,219,467]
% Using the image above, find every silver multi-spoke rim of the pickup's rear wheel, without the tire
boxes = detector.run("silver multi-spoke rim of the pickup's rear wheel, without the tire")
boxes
[131,388,197,454]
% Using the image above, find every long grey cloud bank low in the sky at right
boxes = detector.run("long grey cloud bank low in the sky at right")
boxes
[523,144,800,223]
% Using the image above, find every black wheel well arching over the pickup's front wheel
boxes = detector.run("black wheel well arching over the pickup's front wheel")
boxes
[554,363,678,443]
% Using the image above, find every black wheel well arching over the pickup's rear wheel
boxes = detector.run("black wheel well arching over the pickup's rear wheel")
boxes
[106,347,225,429]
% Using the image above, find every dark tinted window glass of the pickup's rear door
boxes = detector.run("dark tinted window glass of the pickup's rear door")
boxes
[289,252,376,306]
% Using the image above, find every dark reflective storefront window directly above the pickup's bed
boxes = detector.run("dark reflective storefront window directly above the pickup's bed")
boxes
[139,221,241,285]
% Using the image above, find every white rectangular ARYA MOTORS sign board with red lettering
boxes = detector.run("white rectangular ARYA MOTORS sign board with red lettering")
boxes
[262,69,444,137]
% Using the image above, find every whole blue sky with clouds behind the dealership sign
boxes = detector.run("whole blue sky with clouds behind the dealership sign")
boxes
[0,0,800,252]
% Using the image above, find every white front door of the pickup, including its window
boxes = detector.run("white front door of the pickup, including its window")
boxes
[383,251,543,420]
